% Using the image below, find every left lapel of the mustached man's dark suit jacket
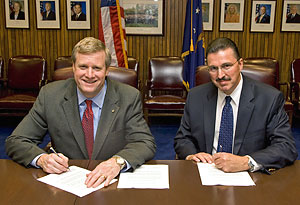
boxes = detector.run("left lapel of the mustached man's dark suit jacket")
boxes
[204,84,218,153]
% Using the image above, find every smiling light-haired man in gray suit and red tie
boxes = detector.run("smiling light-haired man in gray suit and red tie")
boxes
[6,37,156,187]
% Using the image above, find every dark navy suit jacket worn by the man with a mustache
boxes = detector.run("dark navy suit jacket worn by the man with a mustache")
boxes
[174,76,298,169]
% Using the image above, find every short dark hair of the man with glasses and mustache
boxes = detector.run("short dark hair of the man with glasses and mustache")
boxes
[206,38,241,59]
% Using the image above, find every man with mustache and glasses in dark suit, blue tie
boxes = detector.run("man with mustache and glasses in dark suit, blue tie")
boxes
[174,38,298,172]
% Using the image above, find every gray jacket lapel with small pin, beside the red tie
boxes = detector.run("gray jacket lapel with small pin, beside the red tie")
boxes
[92,79,120,159]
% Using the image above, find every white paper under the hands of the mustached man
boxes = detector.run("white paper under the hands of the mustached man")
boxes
[197,163,255,186]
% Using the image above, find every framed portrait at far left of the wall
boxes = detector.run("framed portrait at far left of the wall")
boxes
[5,0,29,28]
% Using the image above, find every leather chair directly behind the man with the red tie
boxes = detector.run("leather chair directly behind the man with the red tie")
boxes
[52,67,138,88]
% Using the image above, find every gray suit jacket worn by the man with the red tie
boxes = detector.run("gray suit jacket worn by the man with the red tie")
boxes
[6,79,156,169]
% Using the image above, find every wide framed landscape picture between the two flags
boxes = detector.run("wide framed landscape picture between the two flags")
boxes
[123,0,164,35]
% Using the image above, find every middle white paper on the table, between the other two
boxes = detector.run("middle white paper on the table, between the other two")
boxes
[118,164,169,189]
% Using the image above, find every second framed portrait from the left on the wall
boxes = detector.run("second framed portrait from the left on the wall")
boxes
[36,0,60,29]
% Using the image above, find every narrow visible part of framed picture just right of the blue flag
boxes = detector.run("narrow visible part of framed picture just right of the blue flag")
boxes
[202,0,214,31]
